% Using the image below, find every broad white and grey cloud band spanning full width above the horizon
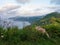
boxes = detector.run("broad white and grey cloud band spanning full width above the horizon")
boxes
[0,5,60,17]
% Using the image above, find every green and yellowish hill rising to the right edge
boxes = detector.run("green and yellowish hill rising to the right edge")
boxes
[34,12,60,25]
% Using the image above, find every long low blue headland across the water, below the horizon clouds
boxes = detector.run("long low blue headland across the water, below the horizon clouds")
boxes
[9,16,44,23]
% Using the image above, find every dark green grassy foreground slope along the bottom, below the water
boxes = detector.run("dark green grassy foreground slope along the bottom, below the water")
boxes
[0,27,60,45]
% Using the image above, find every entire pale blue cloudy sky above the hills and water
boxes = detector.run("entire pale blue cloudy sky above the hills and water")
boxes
[0,0,60,17]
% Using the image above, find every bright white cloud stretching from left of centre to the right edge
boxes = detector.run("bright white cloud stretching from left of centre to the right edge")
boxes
[17,6,60,16]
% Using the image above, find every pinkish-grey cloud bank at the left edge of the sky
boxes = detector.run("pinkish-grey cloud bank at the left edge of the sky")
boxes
[0,4,20,17]
